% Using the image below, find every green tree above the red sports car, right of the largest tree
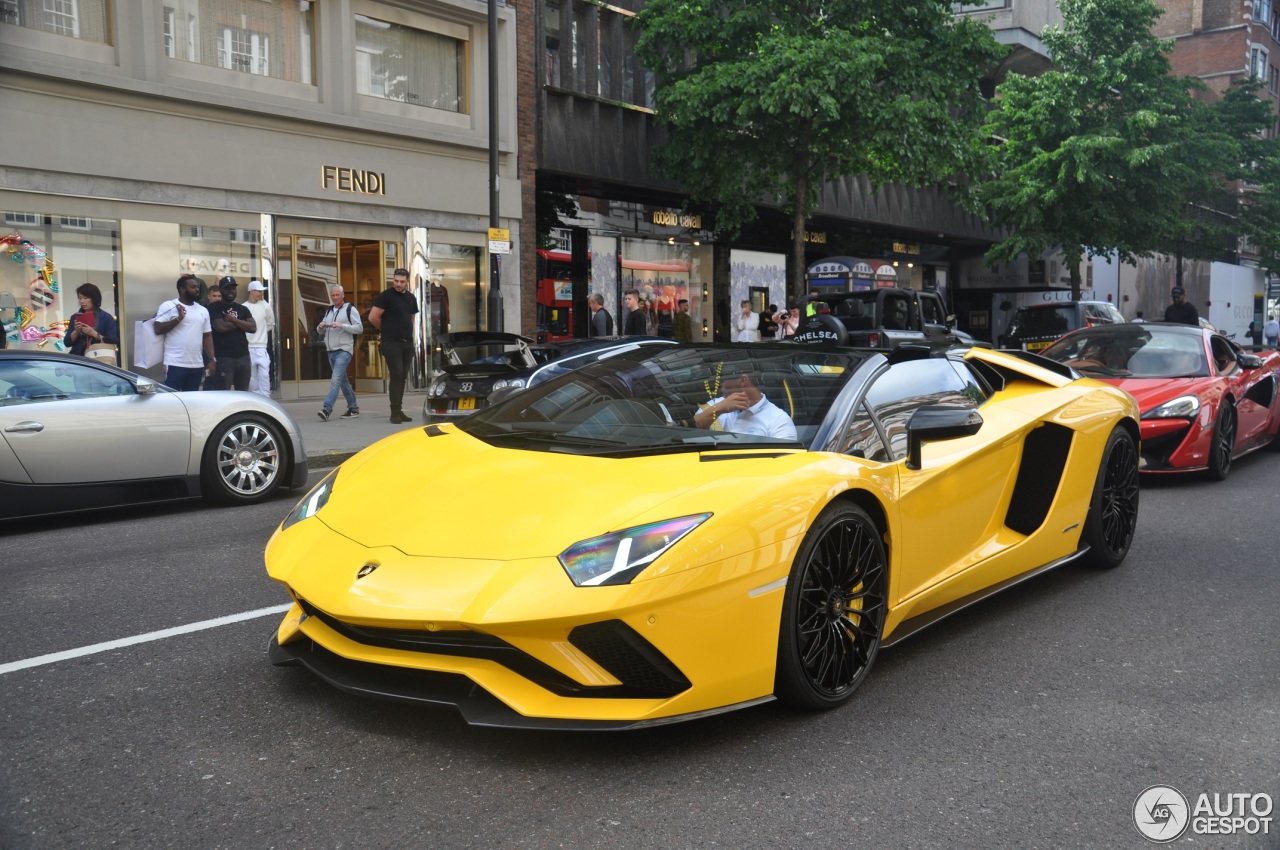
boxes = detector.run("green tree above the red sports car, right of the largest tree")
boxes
[979,0,1203,300]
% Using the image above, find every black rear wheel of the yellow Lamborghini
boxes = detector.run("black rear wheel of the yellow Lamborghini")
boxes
[1082,426,1139,570]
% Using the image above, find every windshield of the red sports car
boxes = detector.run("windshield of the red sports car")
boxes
[1041,324,1208,378]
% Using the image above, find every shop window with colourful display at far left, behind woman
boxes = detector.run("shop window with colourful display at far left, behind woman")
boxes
[0,210,122,351]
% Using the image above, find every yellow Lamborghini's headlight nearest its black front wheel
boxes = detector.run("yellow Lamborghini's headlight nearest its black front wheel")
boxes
[559,513,712,588]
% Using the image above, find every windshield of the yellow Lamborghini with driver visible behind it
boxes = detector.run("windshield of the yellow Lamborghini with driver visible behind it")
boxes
[458,346,869,456]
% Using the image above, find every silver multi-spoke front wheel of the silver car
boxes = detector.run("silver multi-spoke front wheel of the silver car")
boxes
[200,413,288,504]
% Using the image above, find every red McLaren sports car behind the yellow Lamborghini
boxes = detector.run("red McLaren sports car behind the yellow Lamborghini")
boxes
[1041,323,1280,480]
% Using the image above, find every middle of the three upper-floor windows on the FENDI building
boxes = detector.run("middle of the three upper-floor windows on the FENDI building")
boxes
[161,0,315,84]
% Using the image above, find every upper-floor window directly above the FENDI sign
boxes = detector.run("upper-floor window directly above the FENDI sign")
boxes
[356,15,467,113]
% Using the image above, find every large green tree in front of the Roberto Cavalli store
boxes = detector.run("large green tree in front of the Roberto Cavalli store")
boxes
[636,0,1004,297]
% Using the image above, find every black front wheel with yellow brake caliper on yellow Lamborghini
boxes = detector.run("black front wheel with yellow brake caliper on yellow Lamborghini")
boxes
[774,502,888,709]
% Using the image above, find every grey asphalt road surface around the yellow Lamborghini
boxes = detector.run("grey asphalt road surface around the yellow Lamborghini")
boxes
[0,453,1280,850]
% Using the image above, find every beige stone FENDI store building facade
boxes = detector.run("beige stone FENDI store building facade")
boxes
[0,0,522,398]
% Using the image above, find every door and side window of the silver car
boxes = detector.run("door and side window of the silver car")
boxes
[0,357,191,484]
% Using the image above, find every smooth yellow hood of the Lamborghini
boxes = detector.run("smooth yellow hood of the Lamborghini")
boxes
[317,426,777,561]
